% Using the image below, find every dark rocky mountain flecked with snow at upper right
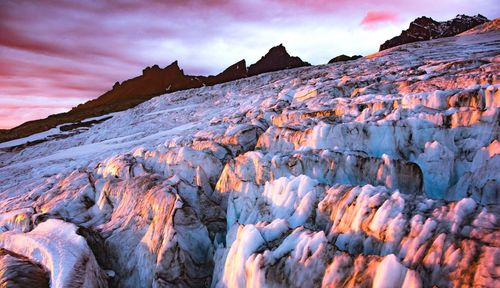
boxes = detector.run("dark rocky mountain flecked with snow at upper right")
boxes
[380,14,489,51]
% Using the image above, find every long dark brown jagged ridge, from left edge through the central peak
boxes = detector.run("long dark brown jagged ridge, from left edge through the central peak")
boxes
[0,45,302,143]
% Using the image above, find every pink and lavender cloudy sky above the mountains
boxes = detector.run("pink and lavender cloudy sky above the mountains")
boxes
[0,0,500,129]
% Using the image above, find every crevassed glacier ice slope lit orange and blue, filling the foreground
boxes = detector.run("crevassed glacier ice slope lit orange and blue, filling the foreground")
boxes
[0,26,500,287]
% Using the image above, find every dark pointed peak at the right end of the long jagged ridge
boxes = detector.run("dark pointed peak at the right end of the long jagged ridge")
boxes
[248,44,311,76]
